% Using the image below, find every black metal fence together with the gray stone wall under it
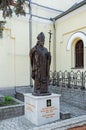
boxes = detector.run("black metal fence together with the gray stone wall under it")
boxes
[50,70,86,110]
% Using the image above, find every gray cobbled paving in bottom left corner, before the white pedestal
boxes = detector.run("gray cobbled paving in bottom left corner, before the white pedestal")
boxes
[0,116,35,130]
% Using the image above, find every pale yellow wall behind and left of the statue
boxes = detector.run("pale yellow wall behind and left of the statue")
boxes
[0,6,53,88]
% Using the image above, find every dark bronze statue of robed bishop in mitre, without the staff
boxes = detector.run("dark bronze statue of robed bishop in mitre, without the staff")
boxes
[30,32,51,96]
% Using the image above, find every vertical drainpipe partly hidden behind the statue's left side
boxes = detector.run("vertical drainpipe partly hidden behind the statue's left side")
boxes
[29,0,33,86]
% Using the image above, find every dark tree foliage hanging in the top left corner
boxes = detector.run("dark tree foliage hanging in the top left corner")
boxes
[0,0,26,18]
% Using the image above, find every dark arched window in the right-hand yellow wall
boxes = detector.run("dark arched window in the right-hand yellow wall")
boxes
[75,40,84,68]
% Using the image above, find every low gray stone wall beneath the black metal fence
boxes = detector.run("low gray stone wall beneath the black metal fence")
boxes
[50,86,86,110]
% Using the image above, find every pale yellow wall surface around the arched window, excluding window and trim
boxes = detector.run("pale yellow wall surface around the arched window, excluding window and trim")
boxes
[56,6,86,71]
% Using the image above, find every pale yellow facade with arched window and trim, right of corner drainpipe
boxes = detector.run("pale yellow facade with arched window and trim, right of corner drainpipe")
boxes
[55,1,86,71]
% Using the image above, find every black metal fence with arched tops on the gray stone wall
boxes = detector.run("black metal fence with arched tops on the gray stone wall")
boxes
[50,70,86,89]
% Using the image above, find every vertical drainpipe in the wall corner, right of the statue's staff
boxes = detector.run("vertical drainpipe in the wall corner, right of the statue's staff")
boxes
[53,19,56,71]
